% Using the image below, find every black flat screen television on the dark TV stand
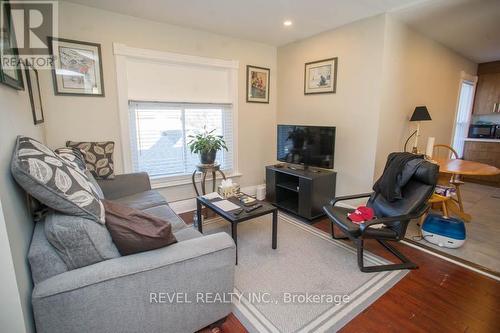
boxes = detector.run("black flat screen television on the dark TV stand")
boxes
[277,125,335,169]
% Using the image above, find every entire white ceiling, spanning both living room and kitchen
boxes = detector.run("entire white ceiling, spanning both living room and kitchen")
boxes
[67,0,500,63]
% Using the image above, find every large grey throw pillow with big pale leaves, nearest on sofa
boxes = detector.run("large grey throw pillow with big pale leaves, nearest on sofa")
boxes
[11,136,105,224]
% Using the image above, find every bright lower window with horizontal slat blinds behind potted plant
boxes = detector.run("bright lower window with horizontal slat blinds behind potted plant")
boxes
[129,101,233,177]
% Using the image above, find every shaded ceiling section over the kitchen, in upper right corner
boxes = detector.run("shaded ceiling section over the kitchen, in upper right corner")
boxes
[392,0,500,63]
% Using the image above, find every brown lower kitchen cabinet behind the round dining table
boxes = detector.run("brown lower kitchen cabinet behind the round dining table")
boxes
[462,141,500,187]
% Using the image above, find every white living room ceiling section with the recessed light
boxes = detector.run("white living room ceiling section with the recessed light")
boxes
[64,0,421,46]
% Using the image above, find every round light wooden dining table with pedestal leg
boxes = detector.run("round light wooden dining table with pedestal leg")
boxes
[433,157,500,222]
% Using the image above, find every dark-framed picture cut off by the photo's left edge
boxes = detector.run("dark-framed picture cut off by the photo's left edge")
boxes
[0,1,24,90]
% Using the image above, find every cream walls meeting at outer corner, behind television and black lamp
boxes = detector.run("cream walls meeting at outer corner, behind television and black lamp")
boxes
[277,14,477,189]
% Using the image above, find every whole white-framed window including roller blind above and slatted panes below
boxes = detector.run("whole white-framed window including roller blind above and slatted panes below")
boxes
[114,44,239,180]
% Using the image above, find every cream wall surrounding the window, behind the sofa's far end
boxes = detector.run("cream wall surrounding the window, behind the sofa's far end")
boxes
[41,2,277,201]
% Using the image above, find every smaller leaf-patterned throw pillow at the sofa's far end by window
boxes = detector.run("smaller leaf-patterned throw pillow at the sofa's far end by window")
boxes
[66,141,115,179]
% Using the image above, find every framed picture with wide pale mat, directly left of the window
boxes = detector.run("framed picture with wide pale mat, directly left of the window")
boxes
[48,37,104,97]
